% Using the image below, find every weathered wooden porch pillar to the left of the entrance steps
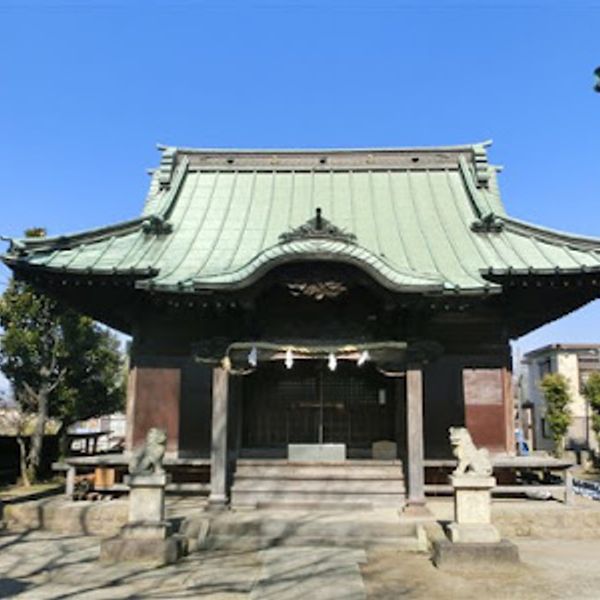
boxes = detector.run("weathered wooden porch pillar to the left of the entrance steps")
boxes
[209,367,229,505]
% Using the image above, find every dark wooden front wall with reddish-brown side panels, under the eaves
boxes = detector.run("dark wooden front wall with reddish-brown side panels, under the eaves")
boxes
[124,270,512,458]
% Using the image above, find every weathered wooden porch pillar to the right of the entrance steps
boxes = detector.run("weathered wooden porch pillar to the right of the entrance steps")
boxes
[406,367,425,507]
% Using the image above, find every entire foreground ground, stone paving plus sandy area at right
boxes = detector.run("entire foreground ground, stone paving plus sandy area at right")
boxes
[0,531,600,600]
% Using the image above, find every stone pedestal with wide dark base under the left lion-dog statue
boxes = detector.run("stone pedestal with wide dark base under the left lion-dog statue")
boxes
[100,473,183,565]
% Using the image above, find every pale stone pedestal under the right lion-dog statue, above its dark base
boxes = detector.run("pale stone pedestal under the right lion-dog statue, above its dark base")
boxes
[448,475,500,543]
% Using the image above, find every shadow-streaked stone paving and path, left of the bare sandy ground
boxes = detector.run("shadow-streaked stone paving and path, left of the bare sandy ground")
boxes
[0,531,366,600]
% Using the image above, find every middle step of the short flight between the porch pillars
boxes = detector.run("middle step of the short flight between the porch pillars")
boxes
[234,477,405,495]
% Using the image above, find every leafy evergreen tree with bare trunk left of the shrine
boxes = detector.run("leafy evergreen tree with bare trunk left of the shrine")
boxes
[0,248,125,485]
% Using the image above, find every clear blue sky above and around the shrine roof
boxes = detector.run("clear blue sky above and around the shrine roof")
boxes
[0,0,600,364]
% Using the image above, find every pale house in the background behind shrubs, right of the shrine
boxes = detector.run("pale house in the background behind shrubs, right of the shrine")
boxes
[521,344,600,450]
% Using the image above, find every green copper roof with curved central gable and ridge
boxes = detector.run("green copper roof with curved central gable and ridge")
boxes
[4,144,600,292]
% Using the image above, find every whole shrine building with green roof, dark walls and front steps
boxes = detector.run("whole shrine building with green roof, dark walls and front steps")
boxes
[3,143,600,505]
